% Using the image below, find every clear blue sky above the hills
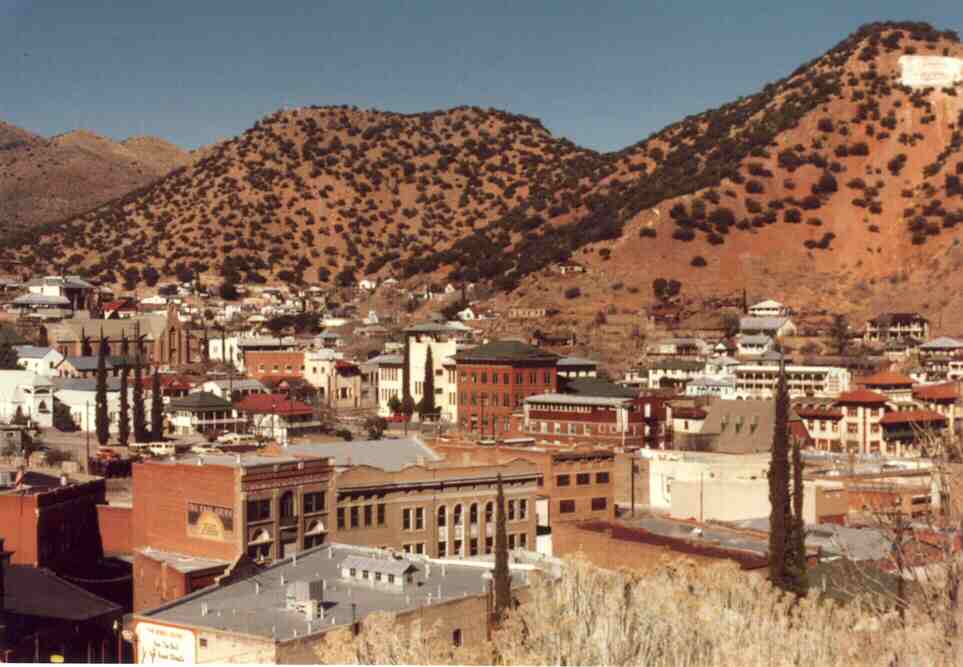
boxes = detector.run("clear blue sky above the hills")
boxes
[0,0,963,151]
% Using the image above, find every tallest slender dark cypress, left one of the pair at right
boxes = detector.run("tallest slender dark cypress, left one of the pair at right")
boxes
[768,365,791,590]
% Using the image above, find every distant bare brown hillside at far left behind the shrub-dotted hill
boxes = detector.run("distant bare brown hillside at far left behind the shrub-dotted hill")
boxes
[0,122,190,230]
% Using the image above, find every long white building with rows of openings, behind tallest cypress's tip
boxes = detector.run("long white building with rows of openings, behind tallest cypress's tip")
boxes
[733,362,852,399]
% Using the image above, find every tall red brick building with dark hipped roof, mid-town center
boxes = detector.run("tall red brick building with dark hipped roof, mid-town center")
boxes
[454,340,559,437]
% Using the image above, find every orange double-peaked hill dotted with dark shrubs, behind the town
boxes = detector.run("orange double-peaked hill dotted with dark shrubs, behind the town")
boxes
[9,23,963,332]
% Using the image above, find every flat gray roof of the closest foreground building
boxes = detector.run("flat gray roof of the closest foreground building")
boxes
[136,544,527,641]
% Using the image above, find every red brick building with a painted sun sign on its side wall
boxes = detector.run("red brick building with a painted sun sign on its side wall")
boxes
[131,455,334,609]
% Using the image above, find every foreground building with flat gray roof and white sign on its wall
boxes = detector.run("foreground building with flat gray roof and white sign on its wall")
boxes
[127,544,537,664]
